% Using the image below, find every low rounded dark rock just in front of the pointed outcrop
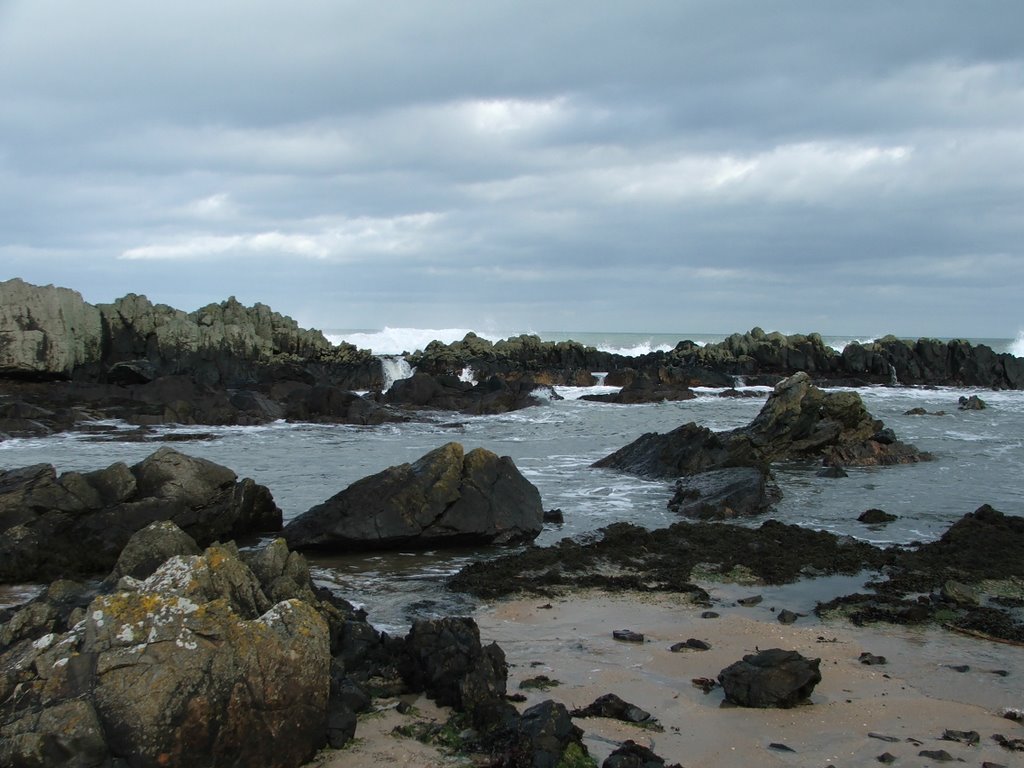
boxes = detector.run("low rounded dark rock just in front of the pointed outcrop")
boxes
[669,467,782,520]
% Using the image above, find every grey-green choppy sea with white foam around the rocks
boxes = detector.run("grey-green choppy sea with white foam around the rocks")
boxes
[0,329,1024,633]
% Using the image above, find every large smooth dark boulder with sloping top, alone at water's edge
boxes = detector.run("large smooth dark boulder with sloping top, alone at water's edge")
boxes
[284,442,544,551]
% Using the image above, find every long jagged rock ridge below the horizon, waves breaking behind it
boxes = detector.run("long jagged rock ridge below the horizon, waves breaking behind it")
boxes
[0,279,1024,439]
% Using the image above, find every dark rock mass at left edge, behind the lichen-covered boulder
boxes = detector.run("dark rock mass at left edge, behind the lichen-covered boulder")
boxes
[0,447,282,582]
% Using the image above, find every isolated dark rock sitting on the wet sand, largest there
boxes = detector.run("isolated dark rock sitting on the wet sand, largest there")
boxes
[718,648,821,709]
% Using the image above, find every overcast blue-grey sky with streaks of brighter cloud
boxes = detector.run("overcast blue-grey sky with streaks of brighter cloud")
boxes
[0,0,1024,338]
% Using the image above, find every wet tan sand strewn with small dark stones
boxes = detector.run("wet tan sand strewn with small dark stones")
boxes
[319,588,1024,768]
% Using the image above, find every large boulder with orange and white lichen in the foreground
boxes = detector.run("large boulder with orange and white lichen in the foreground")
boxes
[0,546,331,768]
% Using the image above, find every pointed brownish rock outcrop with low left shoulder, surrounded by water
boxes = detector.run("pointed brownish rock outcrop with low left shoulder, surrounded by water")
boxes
[594,373,931,477]
